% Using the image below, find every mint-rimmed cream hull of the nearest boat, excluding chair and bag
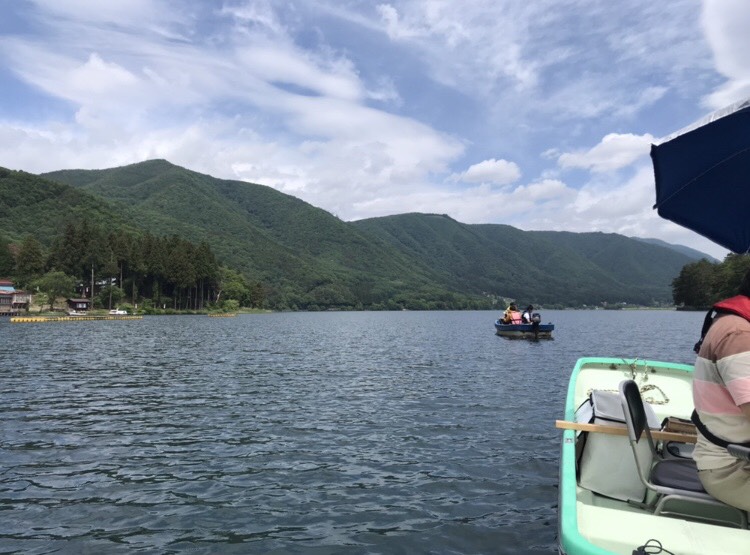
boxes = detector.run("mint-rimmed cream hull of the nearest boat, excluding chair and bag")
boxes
[558,358,750,555]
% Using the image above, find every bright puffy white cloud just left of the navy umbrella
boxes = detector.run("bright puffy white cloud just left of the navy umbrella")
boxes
[557,133,655,172]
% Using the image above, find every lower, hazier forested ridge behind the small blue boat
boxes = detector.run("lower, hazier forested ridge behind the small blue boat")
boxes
[354,214,692,306]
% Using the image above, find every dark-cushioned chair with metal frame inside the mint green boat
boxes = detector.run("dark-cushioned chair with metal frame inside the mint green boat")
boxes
[620,380,747,528]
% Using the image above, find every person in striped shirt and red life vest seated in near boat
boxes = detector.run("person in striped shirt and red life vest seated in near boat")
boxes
[692,271,750,511]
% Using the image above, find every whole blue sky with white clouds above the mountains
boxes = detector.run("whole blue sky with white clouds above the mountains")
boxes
[0,0,750,259]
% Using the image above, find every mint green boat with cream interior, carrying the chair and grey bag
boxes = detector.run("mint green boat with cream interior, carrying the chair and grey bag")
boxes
[557,358,750,555]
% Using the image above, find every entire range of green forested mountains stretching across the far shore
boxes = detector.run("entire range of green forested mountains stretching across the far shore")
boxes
[0,160,712,309]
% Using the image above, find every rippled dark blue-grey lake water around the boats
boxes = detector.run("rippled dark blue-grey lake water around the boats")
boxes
[0,311,703,554]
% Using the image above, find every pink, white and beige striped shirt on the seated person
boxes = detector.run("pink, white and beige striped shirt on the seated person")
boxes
[693,314,750,470]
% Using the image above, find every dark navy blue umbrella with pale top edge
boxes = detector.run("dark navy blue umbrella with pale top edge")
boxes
[651,99,750,254]
